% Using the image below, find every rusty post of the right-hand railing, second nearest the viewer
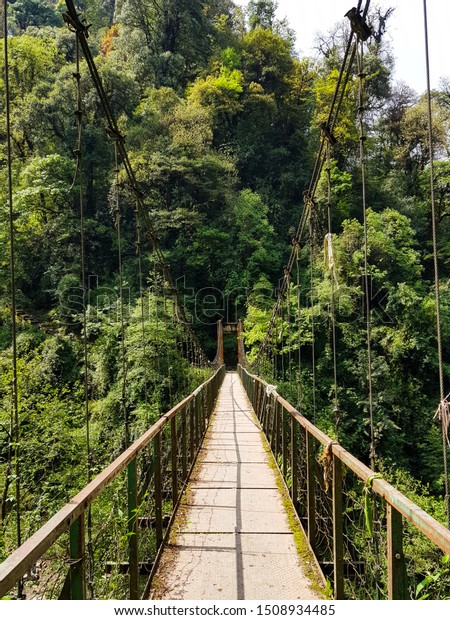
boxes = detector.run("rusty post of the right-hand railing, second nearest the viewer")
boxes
[333,454,344,601]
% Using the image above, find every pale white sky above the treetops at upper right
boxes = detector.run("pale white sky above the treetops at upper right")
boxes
[235,0,450,93]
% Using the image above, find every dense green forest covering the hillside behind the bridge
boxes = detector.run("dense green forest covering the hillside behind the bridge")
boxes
[0,0,450,596]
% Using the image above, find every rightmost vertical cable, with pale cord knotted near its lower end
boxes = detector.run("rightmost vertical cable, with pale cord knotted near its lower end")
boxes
[423,0,450,529]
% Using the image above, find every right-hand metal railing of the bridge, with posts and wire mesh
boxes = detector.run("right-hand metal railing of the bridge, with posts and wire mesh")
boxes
[238,366,450,600]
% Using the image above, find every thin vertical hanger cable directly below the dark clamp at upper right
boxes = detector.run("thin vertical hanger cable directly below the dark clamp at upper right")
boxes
[357,41,376,470]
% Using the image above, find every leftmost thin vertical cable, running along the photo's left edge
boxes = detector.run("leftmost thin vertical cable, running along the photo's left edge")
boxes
[3,0,24,599]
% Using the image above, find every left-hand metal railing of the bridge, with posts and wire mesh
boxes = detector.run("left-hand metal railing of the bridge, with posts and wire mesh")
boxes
[0,366,225,600]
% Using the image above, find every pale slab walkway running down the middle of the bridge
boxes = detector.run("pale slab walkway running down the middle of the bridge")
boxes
[151,372,320,600]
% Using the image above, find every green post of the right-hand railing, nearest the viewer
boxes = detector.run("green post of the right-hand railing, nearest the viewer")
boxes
[386,503,409,601]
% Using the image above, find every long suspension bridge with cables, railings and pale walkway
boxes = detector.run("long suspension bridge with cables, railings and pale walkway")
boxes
[0,0,450,600]
